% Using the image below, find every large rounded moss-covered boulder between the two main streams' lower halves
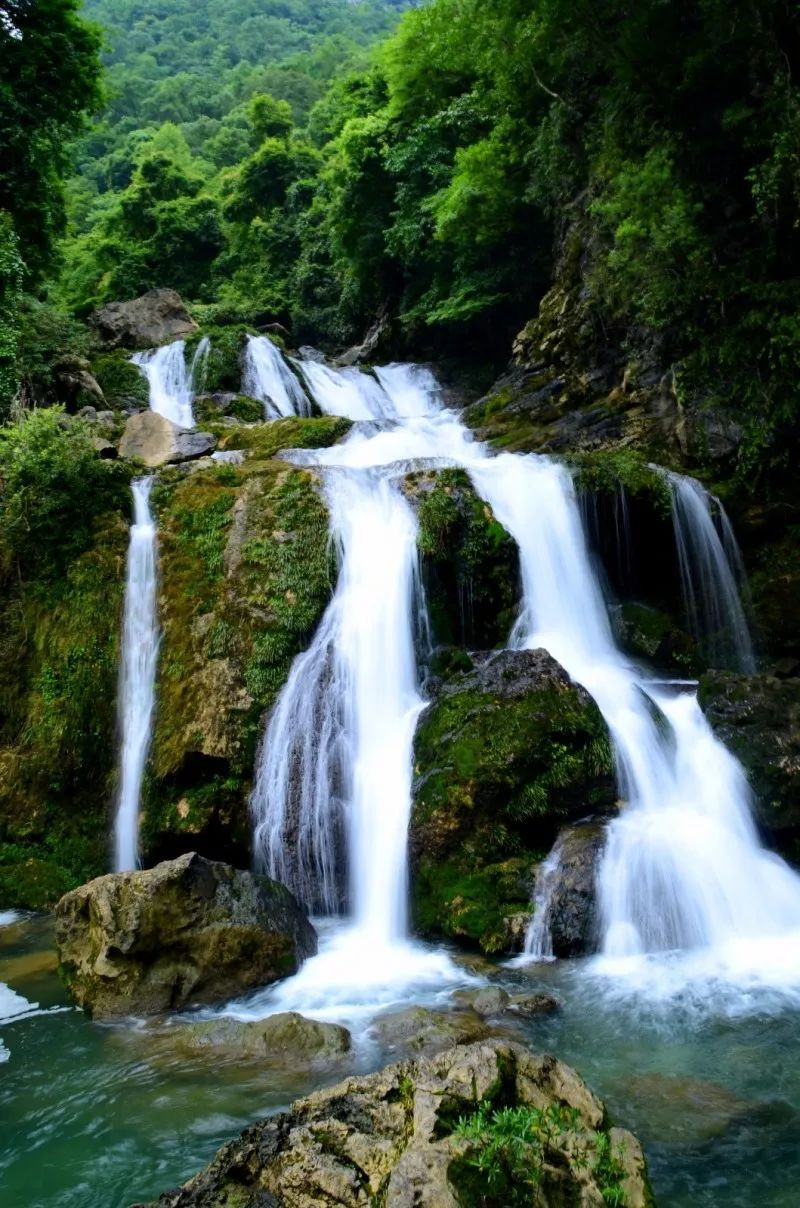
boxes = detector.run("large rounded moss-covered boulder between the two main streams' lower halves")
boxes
[410,650,614,952]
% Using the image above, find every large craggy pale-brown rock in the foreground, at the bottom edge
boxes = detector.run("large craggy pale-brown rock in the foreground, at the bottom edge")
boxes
[138,1040,651,1208]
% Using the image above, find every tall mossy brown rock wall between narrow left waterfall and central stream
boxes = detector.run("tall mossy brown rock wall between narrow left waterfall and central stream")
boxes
[143,419,348,863]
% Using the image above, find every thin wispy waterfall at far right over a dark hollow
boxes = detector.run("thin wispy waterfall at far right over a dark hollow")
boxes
[667,474,755,673]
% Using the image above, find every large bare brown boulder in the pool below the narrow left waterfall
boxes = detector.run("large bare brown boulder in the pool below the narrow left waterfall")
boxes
[56,853,317,1018]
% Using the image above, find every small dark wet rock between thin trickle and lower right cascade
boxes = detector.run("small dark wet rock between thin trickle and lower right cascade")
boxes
[550,823,605,957]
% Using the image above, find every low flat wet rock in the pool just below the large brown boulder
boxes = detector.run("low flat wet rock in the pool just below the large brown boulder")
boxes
[162,1011,352,1067]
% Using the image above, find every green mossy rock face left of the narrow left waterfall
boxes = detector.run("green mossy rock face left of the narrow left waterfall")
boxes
[0,517,127,910]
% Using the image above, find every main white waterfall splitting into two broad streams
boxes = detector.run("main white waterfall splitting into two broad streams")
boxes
[242,352,800,1010]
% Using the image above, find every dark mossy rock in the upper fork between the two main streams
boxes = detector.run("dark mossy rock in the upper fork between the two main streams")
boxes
[405,470,520,650]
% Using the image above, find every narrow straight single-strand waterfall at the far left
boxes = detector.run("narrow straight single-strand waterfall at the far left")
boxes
[114,477,158,872]
